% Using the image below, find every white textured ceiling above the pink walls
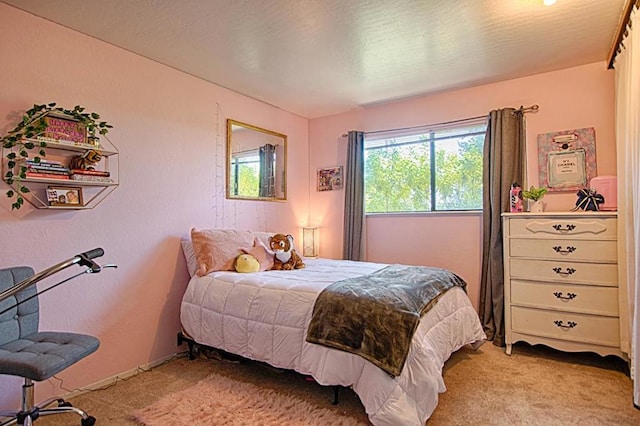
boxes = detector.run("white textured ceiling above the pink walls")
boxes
[0,0,625,118]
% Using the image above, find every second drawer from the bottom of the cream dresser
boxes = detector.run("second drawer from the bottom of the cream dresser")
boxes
[511,280,619,317]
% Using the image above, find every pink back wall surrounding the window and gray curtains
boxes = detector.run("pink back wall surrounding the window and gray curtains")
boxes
[309,62,616,307]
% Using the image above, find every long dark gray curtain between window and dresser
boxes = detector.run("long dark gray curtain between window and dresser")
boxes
[479,108,525,346]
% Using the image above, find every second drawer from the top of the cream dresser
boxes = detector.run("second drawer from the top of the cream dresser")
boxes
[509,238,618,263]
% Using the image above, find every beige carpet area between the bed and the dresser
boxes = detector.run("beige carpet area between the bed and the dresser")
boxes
[428,342,640,426]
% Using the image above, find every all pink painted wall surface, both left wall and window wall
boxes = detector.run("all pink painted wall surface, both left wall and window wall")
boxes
[0,0,615,410]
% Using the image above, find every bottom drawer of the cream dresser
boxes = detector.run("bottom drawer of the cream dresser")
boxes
[511,306,620,346]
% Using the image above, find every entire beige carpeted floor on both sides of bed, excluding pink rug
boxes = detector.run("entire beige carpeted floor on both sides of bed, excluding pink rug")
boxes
[26,343,640,426]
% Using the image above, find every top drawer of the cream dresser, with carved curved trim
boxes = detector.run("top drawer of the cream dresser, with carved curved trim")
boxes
[508,217,618,239]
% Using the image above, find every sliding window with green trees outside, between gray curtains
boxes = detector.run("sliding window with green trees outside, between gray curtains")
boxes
[364,117,487,213]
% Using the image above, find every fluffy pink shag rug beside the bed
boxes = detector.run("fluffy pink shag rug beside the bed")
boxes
[133,374,360,426]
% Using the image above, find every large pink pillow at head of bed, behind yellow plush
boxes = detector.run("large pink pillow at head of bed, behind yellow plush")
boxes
[191,228,253,277]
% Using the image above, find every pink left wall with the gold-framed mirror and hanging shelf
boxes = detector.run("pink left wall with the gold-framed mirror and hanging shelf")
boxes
[0,4,308,410]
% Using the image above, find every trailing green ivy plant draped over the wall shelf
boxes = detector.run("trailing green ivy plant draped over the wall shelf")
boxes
[0,102,113,210]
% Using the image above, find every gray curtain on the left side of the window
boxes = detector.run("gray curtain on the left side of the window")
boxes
[342,131,364,260]
